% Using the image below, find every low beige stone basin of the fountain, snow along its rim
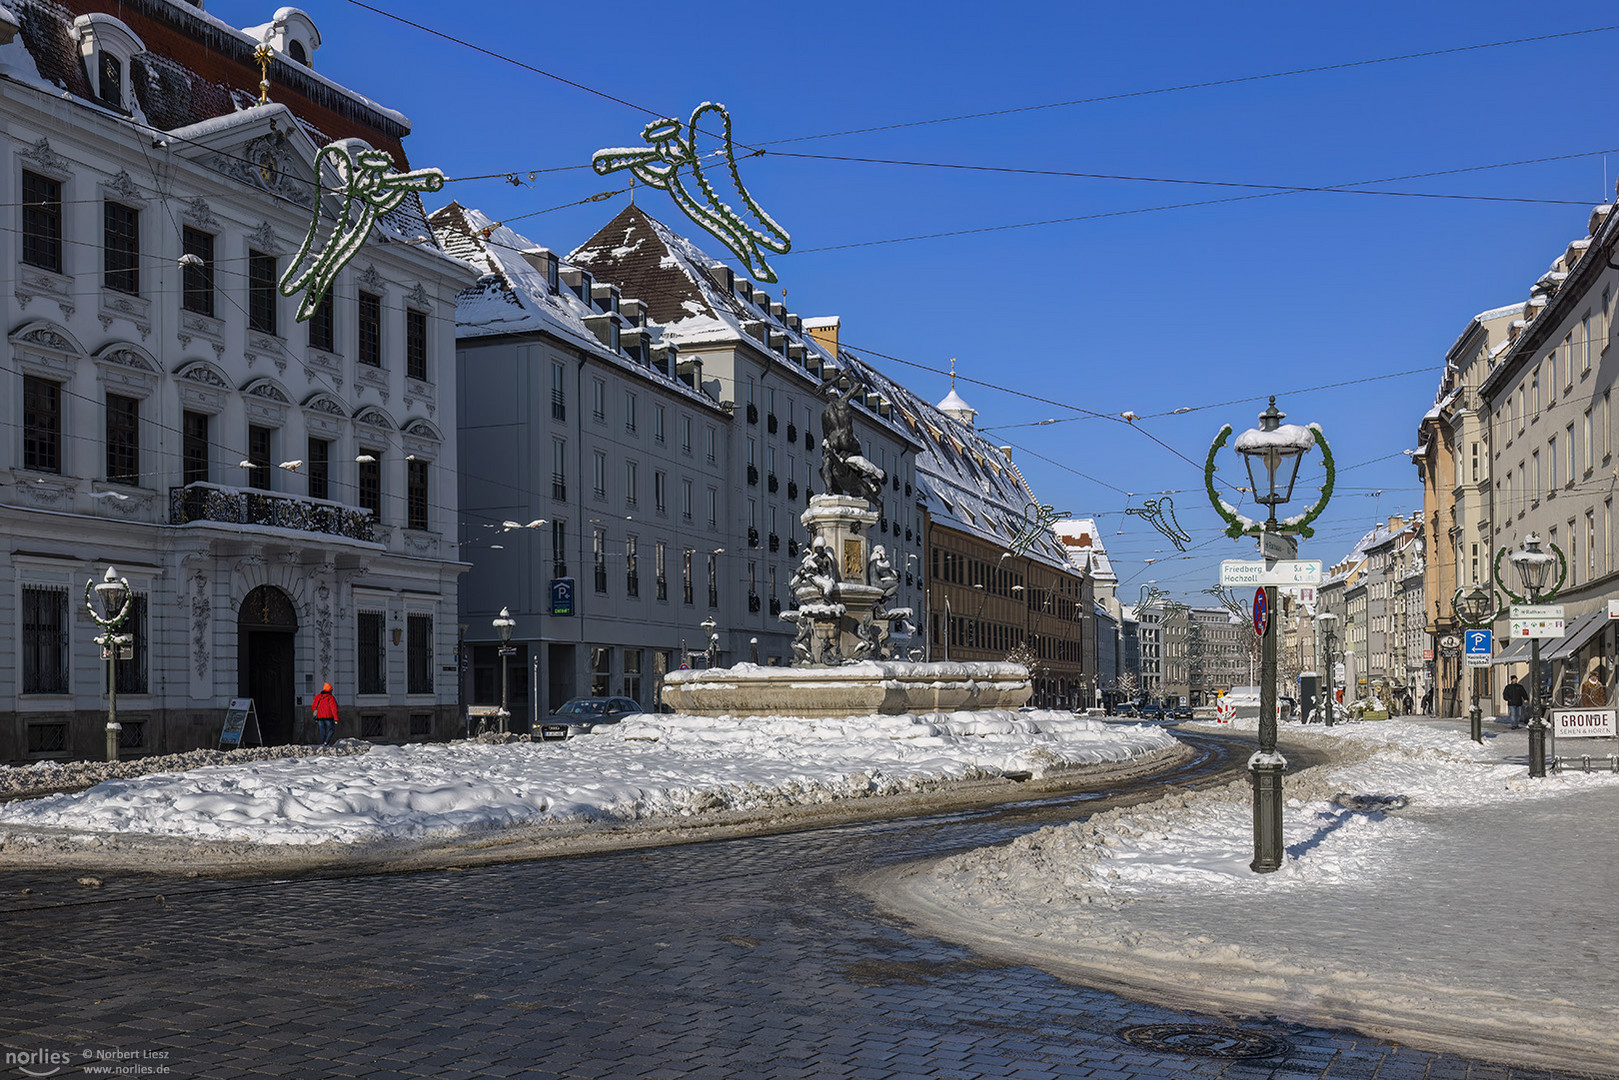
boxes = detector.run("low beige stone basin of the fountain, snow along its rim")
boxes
[664,661,1035,716]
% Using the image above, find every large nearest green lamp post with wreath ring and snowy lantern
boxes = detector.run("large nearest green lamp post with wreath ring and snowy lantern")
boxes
[1203,397,1334,874]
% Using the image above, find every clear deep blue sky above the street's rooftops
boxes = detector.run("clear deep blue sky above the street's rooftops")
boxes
[207,0,1619,599]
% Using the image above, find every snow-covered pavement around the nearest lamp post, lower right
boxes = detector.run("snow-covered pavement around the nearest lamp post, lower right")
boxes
[881,721,1619,1065]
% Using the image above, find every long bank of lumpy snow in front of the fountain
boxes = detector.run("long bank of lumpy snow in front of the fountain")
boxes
[0,711,1175,845]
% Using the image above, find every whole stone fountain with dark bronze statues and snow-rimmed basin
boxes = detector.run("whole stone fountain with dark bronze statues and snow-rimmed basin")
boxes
[664,387,1033,716]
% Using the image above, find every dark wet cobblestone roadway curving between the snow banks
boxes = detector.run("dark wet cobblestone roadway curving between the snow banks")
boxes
[0,735,1599,1080]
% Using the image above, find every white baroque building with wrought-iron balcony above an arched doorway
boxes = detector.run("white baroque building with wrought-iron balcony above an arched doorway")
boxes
[0,0,471,761]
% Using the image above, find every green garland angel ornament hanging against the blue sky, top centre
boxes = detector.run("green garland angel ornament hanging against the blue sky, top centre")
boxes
[591,102,793,282]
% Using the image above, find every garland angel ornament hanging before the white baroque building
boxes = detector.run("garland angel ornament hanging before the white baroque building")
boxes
[280,139,444,322]
